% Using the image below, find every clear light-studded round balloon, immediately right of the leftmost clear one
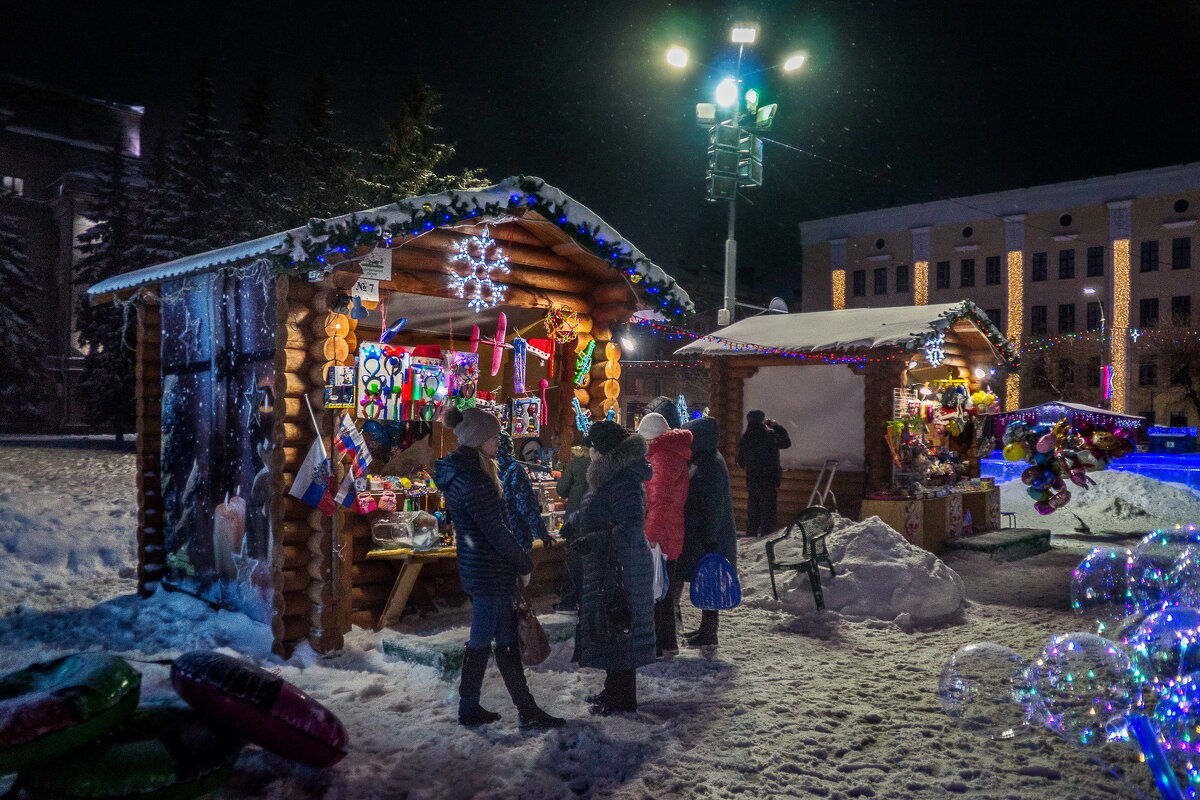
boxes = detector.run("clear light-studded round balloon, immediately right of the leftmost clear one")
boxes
[1020,632,1141,745]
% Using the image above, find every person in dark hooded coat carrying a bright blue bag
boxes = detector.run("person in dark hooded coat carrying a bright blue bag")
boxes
[673,416,738,658]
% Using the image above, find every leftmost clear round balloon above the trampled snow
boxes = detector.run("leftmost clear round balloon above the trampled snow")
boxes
[937,642,1028,739]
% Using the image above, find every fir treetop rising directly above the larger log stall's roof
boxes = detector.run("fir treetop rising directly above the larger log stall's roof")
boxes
[368,83,488,205]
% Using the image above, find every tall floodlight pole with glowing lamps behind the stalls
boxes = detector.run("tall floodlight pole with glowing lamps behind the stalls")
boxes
[667,25,805,326]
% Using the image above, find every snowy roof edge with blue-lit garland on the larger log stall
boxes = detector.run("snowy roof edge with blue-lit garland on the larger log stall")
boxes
[88,176,695,314]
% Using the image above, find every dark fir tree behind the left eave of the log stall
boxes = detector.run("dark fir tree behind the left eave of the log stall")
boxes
[74,139,140,439]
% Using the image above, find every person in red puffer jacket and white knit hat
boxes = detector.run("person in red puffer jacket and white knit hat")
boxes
[637,414,691,661]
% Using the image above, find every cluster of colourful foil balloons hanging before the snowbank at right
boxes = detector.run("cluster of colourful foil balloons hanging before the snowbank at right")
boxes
[1002,419,1133,515]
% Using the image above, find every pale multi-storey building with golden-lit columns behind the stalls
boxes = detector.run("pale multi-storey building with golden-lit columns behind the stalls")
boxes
[800,163,1200,426]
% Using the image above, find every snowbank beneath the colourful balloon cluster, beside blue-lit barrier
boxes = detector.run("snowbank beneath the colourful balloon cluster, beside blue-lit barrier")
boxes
[1000,469,1200,533]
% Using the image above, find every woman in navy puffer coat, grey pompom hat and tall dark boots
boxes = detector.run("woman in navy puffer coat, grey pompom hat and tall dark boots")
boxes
[434,408,565,730]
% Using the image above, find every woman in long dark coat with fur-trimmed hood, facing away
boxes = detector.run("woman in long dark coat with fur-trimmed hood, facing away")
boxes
[572,421,654,715]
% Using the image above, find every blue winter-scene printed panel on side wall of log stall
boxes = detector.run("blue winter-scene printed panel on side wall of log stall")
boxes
[162,265,275,621]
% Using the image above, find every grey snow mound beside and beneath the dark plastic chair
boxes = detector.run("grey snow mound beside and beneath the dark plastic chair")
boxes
[738,517,966,628]
